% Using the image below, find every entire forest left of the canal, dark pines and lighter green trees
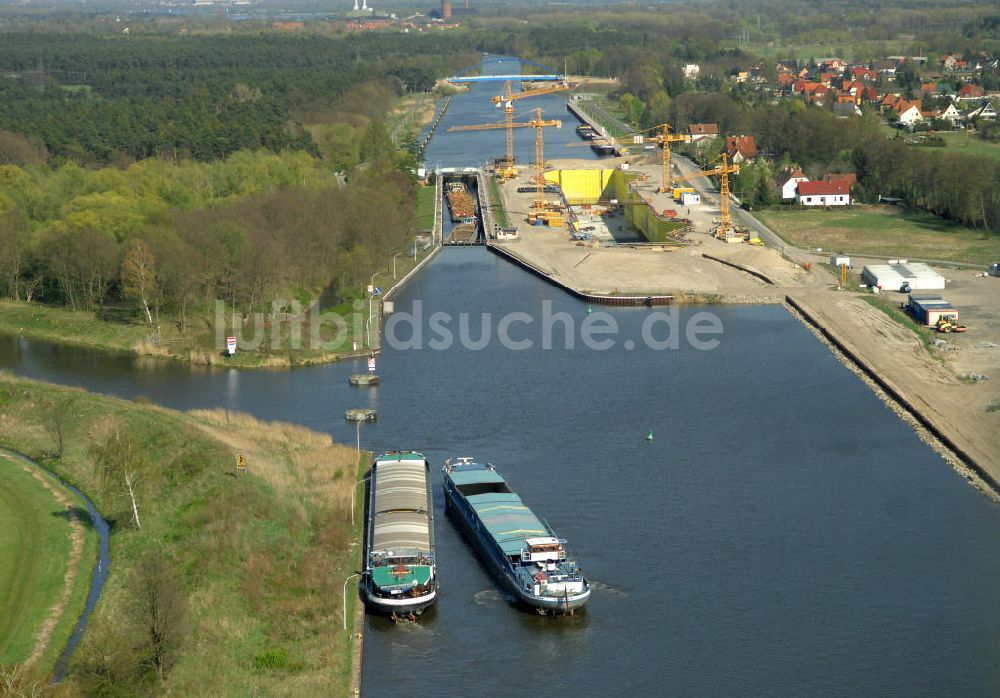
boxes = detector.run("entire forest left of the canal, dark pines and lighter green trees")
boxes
[0,33,470,342]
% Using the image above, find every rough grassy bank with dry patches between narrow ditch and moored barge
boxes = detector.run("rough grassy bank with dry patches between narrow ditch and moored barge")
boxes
[0,374,361,696]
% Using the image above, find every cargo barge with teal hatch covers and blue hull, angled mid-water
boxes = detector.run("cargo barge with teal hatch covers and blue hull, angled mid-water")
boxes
[443,458,590,615]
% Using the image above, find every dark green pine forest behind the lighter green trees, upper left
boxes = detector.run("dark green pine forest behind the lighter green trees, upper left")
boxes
[0,33,472,164]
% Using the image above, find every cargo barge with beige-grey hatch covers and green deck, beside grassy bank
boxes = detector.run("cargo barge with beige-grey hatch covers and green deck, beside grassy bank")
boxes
[360,451,438,620]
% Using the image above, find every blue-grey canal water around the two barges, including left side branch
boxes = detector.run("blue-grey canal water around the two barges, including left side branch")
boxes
[0,57,1000,696]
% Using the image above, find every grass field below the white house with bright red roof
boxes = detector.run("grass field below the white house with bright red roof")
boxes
[754,206,1000,266]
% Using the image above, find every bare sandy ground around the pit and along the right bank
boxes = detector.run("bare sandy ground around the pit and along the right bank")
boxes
[488,153,1000,495]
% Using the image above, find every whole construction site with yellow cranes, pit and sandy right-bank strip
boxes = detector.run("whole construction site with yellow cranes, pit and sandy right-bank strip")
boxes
[436,64,1000,493]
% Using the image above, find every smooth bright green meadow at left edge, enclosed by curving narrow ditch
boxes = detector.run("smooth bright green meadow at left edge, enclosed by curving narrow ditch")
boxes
[0,453,96,673]
